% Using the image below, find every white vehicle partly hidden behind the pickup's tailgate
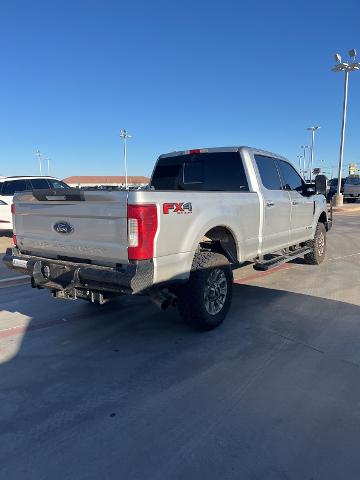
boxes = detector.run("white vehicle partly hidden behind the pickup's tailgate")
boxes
[0,177,70,233]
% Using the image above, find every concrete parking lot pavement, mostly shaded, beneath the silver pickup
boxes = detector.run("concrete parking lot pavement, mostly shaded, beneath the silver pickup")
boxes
[0,214,360,480]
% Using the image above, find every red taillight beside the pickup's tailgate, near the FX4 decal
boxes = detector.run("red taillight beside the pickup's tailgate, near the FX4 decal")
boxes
[128,205,158,260]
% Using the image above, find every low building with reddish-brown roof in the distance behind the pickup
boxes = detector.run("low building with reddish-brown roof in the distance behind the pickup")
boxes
[63,175,150,189]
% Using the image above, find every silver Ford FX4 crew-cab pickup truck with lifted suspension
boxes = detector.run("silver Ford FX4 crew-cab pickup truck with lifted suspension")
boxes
[4,147,332,330]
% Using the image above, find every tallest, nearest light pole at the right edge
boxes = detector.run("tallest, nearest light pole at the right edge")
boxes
[332,48,360,205]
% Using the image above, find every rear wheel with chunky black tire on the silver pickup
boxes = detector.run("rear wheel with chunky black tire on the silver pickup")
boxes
[178,252,233,331]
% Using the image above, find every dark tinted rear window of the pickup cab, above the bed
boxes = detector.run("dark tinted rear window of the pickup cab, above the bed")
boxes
[151,152,249,192]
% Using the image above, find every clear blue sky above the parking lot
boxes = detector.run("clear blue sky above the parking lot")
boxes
[0,0,360,178]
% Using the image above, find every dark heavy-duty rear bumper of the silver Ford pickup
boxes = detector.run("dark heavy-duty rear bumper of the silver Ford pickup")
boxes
[3,247,154,294]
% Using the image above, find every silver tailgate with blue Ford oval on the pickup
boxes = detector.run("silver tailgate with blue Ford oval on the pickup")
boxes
[14,189,128,266]
